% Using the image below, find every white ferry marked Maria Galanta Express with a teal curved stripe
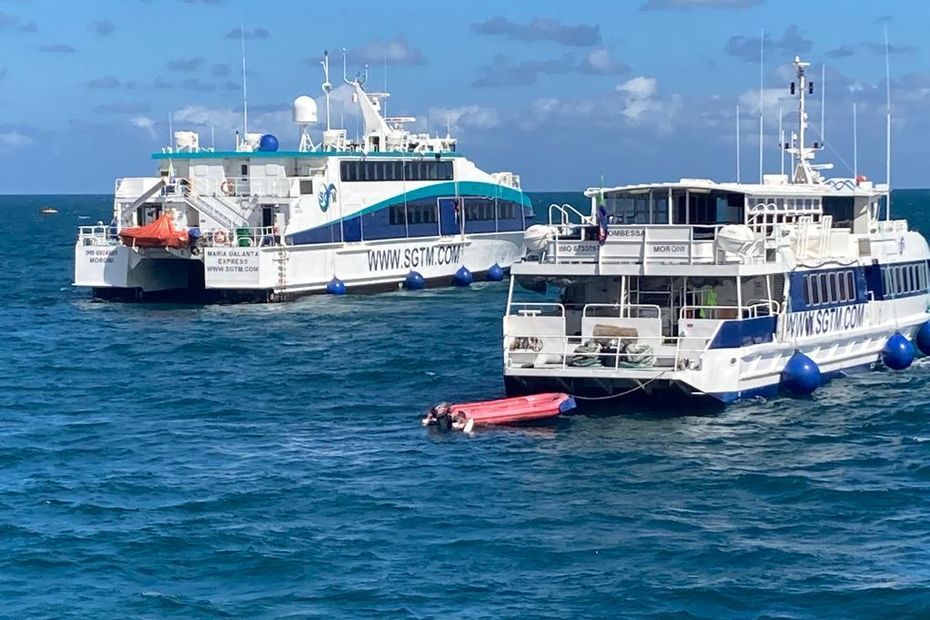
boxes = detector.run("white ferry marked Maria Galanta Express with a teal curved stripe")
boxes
[74,55,533,301]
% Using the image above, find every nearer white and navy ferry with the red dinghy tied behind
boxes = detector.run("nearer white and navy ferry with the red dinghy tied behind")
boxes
[503,58,930,403]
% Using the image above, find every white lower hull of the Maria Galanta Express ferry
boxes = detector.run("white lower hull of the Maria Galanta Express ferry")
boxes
[75,231,523,301]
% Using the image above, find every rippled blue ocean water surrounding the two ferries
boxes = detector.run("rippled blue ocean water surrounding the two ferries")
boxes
[0,191,930,618]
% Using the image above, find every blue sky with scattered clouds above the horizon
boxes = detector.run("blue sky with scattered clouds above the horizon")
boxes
[0,0,930,194]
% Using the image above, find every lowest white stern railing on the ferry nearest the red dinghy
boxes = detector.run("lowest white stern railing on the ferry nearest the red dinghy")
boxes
[504,334,709,373]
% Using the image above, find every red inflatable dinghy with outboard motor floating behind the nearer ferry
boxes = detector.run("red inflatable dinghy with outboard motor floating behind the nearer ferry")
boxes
[423,392,575,433]
